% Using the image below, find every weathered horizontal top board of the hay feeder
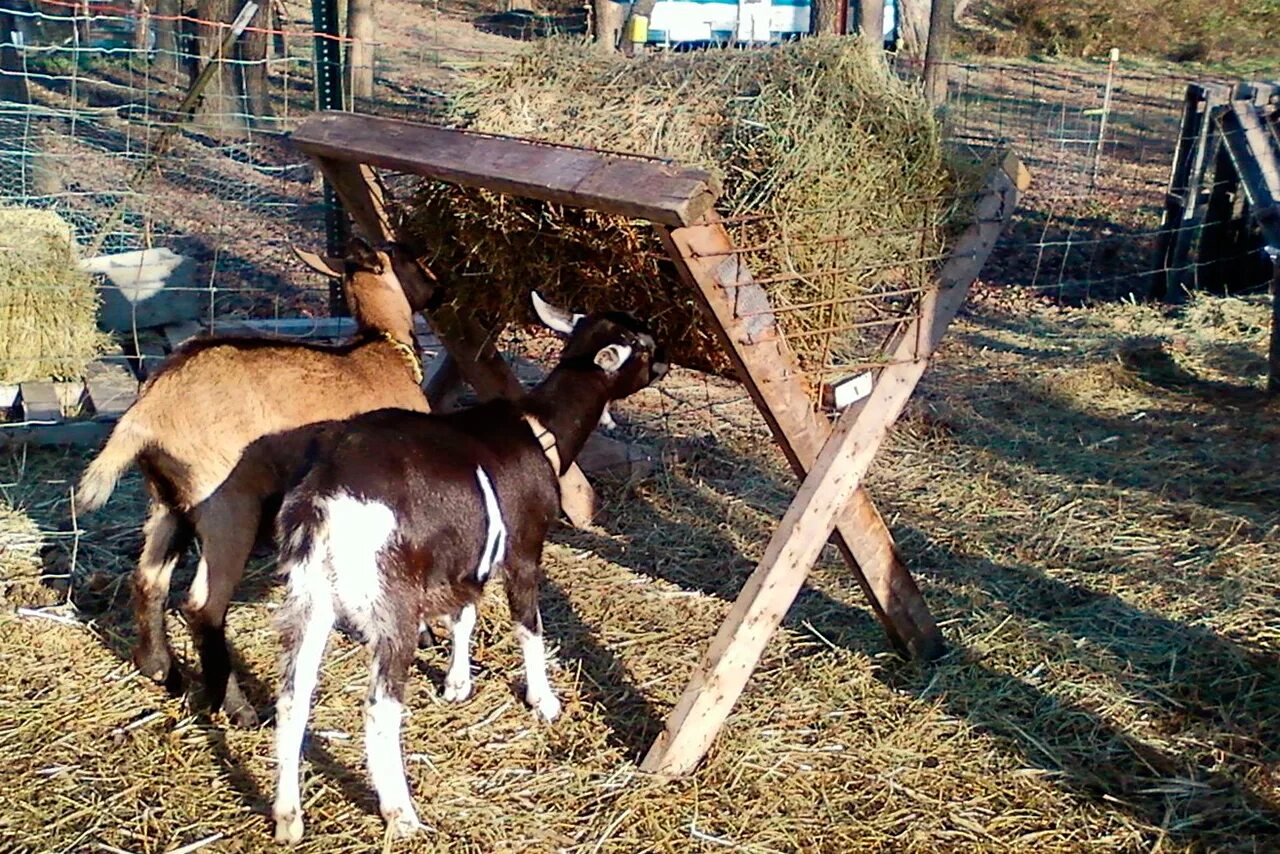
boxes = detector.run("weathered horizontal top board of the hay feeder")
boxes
[291,113,719,225]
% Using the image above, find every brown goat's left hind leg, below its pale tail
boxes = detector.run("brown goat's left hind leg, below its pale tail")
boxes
[133,501,192,694]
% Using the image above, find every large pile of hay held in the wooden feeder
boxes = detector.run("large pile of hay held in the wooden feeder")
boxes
[403,38,956,370]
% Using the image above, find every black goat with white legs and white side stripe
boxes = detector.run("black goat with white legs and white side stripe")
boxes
[273,301,667,842]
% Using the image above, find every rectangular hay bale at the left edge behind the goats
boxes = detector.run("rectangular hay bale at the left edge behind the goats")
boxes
[0,207,108,383]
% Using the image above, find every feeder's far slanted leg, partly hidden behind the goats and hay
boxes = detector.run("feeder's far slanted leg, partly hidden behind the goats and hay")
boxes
[317,153,595,528]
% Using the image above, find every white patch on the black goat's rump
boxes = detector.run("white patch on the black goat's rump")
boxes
[317,493,396,632]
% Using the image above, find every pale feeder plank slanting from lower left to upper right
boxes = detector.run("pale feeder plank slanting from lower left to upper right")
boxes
[640,156,1027,776]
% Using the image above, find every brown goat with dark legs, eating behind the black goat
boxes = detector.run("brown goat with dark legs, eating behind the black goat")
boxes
[77,239,431,726]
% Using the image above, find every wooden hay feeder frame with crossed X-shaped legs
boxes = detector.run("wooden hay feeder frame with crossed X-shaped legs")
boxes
[293,113,1029,776]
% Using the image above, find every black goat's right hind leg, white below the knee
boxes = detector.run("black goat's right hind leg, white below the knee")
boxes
[365,624,419,836]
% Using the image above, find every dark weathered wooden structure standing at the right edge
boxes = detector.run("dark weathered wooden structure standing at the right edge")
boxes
[1151,83,1280,393]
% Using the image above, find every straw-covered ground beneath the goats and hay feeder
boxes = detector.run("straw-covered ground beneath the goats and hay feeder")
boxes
[0,285,1280,854]
